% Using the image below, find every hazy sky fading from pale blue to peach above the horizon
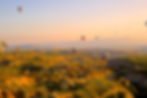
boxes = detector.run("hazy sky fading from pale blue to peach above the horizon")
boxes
[0,0,147,45]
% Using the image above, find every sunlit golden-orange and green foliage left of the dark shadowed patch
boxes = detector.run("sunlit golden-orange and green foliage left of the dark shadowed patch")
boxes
[0,51,133,98]
